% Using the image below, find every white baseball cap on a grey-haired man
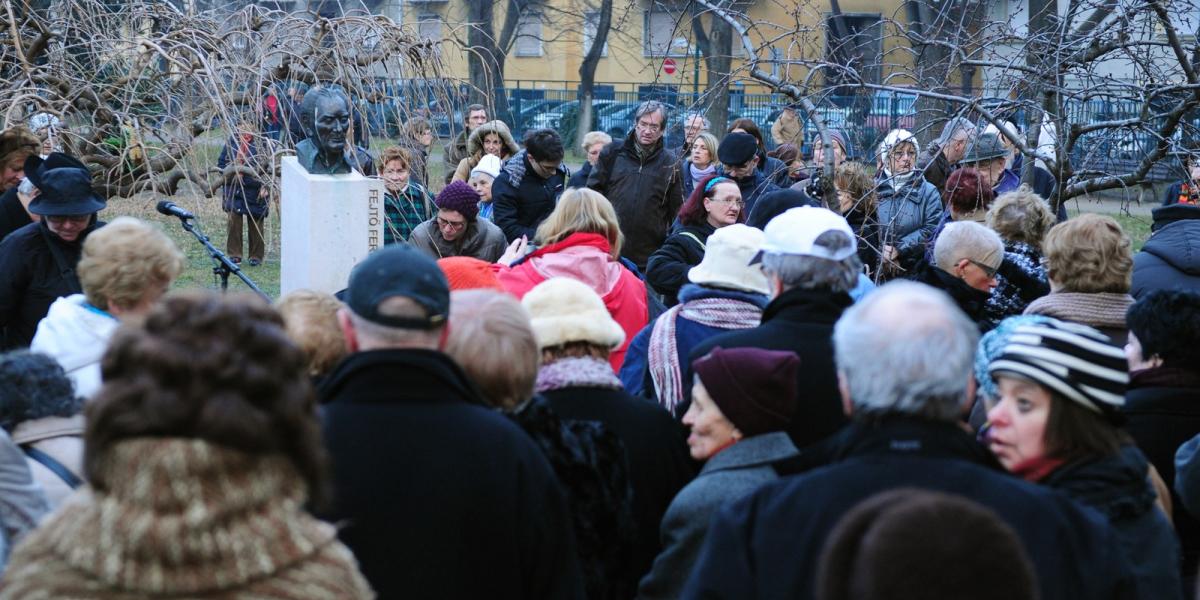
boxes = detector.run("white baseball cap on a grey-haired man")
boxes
[754,206,858,262]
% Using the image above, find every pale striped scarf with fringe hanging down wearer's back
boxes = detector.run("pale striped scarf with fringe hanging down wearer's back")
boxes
[647,298,762,414]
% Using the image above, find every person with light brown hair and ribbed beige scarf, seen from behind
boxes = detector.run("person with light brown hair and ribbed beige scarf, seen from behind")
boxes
[1025,214,1133,346]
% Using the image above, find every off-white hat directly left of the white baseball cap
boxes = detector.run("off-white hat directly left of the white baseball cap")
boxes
[688,223,770,294]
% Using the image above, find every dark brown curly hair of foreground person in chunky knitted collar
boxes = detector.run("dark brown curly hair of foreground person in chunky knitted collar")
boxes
[84,292,328,508]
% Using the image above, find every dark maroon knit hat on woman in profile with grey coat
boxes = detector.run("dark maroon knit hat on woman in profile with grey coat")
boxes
[691,346,800,437]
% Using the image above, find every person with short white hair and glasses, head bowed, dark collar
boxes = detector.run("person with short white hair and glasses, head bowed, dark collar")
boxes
[916,221,1004,331]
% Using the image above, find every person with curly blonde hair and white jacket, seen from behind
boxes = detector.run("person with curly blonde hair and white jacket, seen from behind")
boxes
[30,217,185,398]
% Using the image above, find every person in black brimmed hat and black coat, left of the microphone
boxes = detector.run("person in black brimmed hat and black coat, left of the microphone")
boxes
[0,152,107,349]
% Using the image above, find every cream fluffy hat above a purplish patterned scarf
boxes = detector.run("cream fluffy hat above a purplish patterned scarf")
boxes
[521,277,625,348]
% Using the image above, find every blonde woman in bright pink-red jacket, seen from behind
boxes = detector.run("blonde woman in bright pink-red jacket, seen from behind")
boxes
[497,188,649,371]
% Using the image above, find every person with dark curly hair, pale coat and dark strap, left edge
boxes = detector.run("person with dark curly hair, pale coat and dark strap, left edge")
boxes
[0,350,84,510]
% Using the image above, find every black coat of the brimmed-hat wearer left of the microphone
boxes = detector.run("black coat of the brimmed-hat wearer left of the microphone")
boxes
[0,216,103,349]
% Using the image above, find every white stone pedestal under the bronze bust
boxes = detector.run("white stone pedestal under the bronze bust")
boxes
[280,156,384,294]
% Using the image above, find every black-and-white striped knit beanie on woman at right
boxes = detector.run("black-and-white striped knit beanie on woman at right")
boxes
[988,319,1129,422]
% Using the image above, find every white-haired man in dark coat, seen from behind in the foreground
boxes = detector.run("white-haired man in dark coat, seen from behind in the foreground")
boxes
[683,282,1132,600]
